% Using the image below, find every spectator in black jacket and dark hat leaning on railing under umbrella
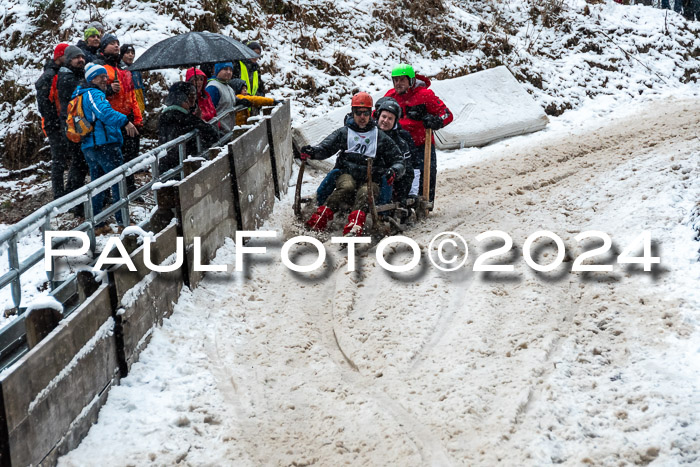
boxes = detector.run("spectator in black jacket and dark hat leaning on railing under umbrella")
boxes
[158,81,219,173]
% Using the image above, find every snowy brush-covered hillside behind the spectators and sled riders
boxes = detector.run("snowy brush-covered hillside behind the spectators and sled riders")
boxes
[0,0,700,167]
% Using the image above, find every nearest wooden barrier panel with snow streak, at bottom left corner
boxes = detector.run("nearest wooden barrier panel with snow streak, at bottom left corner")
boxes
[0,285,118,465]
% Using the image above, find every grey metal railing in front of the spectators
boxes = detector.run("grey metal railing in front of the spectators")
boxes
[0,106,245,316]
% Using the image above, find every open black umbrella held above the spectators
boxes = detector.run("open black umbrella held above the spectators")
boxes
[128,32,259,71]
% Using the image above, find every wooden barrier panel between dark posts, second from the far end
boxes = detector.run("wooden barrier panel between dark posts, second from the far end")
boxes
[229,121,275,230]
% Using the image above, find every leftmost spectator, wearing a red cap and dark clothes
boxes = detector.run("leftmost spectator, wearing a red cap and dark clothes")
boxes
[35,44,68,199]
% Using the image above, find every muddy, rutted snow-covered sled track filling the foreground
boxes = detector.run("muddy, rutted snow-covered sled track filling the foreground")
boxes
[61,99,700,465]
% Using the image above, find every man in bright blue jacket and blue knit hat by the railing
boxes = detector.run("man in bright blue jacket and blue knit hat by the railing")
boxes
[73,64,138,224]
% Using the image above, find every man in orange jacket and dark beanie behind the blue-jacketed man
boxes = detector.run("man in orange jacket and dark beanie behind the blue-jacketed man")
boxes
[95,34,143,193]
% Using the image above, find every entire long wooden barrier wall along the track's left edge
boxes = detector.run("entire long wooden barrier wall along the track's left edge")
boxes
[0,102,292,466]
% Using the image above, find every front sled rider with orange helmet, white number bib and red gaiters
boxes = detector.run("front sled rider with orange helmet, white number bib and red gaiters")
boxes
[301,92,405,236]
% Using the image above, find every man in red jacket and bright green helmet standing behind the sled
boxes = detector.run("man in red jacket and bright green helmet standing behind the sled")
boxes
[385,64,454,202]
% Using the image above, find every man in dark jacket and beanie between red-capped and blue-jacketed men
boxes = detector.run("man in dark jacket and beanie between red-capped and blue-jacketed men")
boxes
[56,45,88,203]
